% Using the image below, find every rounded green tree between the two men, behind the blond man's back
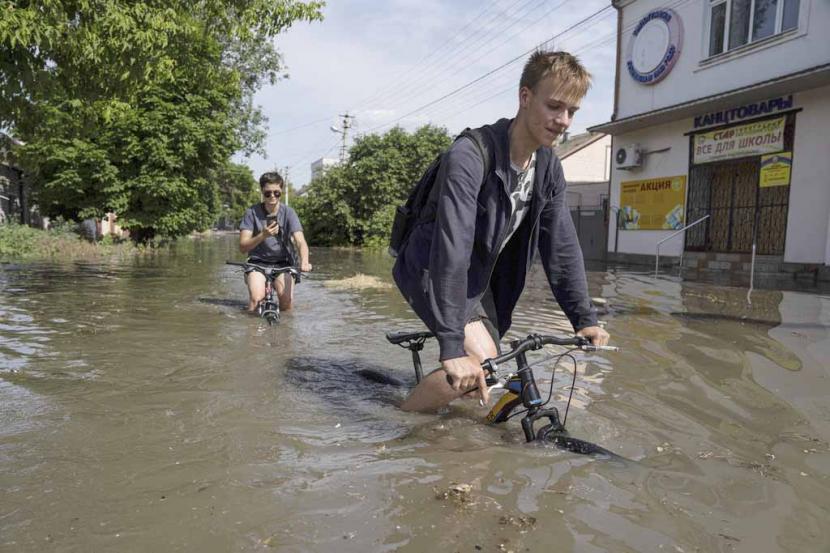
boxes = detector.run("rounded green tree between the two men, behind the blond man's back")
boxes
[294,125,451,245]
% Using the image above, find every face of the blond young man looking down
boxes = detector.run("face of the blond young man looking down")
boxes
[519,77,582,146]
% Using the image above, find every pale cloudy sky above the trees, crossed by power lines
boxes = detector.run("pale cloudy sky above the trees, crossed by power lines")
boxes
[237,0,616,187]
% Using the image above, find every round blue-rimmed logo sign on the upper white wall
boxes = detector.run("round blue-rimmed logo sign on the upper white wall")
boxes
[626,10,683,85]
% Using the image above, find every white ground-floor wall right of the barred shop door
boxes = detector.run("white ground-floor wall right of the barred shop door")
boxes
[784,87,830,263]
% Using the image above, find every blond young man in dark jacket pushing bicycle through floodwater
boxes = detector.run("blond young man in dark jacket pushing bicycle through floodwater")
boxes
[393,52,608,411]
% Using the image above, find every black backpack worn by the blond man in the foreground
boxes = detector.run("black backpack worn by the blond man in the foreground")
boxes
[389,129,492,257]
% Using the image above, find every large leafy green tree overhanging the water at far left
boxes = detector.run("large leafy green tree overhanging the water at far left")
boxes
[0,0,323,239]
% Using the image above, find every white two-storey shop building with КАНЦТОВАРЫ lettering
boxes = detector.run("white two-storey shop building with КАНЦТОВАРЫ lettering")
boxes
[591,0,830,275]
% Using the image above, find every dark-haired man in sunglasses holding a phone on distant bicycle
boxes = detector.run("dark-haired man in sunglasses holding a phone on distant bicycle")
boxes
[239,172,311,311]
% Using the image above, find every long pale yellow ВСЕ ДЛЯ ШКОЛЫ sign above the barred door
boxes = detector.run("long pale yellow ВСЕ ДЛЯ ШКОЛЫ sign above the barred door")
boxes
[694,117,786,163]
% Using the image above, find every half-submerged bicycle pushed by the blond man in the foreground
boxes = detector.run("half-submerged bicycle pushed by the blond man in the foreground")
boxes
[386,331,619,457]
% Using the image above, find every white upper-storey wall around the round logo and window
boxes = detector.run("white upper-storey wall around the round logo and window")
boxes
[617,0,830,119]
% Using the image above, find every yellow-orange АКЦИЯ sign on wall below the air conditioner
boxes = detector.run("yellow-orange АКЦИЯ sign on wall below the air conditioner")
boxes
[619,175,686,230]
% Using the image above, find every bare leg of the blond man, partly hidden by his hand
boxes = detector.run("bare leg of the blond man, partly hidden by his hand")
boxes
[401,321,497,412]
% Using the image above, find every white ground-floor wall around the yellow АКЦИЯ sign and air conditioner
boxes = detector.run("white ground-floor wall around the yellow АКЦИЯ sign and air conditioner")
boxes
[608,119,692,255]
